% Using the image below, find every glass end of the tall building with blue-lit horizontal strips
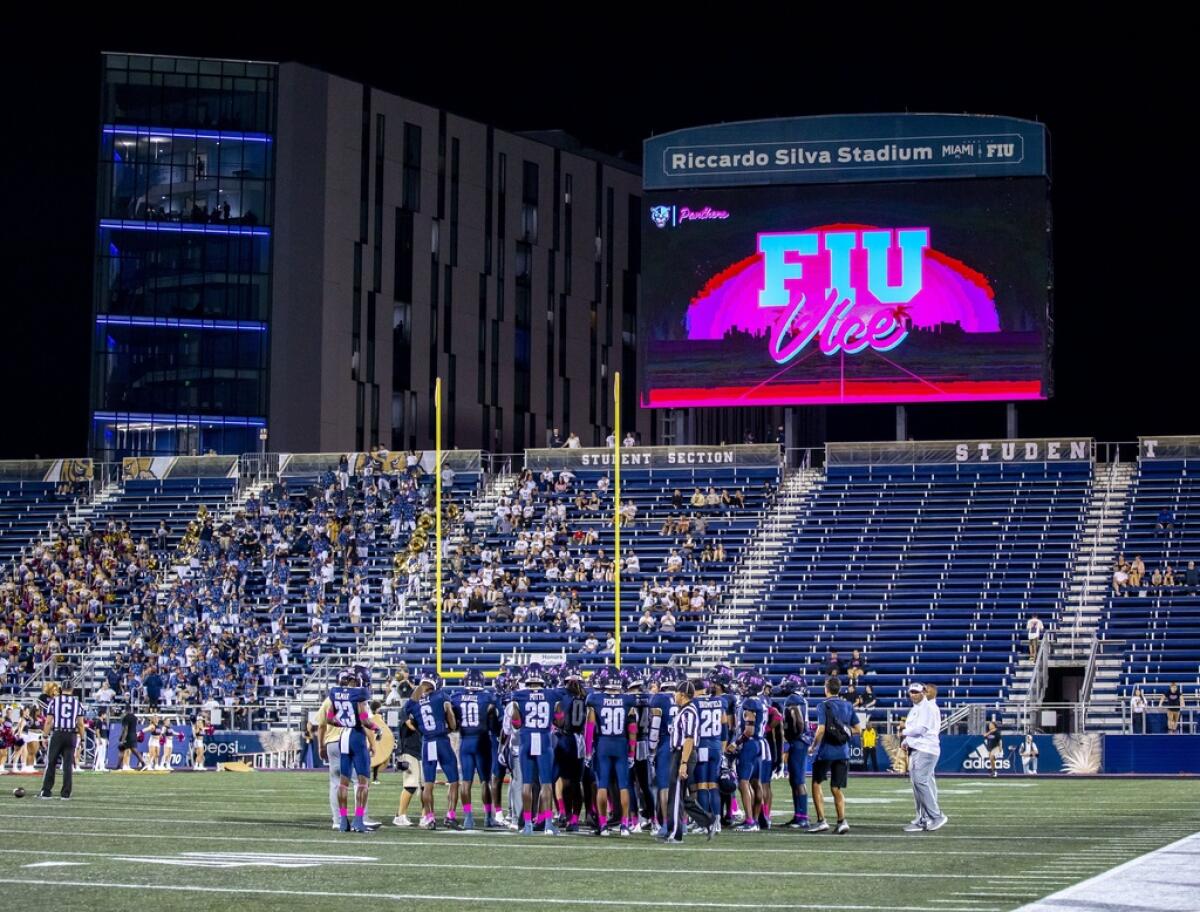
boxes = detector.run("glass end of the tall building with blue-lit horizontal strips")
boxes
[90,54,276,460]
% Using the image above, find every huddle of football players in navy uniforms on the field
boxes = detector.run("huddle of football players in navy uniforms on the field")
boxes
[319,664,858,841]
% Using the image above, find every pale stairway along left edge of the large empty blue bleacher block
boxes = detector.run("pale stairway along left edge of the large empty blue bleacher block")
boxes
[688,469,824,672]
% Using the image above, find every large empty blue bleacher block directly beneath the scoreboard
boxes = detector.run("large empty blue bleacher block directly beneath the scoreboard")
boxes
[734,444,1092,707]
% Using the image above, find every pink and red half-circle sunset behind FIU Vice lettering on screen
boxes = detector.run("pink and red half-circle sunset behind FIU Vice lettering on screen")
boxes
[685,224,1000,364]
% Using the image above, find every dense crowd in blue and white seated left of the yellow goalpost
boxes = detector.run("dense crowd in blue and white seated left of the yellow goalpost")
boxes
[92,450,441,707]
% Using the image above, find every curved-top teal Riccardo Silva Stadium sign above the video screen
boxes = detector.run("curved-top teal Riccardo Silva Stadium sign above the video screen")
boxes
[643,114,1048,190]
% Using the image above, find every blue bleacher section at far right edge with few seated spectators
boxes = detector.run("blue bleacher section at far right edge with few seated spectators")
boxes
[1088,438,1200,731]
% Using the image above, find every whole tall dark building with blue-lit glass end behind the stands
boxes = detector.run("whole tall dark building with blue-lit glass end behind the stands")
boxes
[91,54,654,460]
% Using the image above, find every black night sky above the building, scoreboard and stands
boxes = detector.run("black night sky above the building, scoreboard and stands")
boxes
[0,13,1200,458]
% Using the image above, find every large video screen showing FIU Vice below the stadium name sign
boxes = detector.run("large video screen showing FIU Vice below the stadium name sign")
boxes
[638,178,1052,408]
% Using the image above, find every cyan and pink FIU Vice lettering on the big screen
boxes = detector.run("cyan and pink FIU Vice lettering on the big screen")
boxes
[758,228,929,364]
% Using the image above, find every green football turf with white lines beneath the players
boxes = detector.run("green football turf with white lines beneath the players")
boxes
[0,773,1200,912]
